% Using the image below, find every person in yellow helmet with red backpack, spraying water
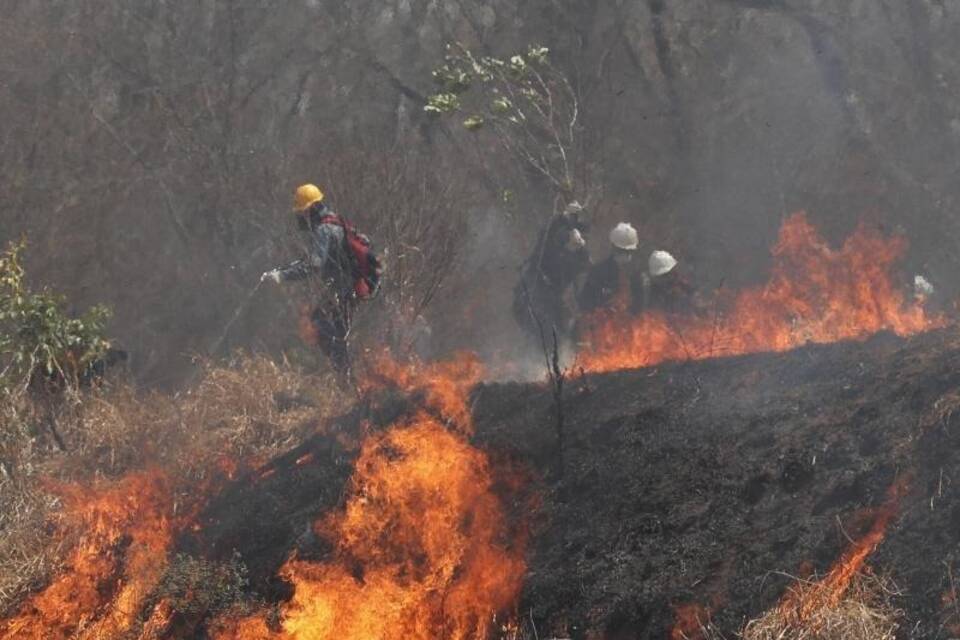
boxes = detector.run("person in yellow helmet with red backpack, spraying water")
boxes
[260,184,382,377]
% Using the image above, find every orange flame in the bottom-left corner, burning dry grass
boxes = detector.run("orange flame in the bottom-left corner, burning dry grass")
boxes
[0,470,175,640]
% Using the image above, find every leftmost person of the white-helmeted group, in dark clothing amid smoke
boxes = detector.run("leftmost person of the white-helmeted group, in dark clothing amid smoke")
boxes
[513,201,590,347]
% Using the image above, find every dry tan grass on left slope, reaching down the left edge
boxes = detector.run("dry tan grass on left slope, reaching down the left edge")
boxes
[0,356,353,616]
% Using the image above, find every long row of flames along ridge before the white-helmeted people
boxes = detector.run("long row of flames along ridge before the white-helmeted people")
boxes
[578,213,943,371]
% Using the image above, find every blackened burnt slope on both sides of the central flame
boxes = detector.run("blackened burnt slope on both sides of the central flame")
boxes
[181,330,960,640]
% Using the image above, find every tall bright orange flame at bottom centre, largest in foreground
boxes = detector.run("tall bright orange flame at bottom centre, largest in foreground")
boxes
[217,357,525,640]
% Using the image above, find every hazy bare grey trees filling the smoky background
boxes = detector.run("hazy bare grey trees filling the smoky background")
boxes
[0,0,960,384]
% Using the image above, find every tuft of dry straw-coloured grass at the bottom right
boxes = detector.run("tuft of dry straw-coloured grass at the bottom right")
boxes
[740,573,903,640]
